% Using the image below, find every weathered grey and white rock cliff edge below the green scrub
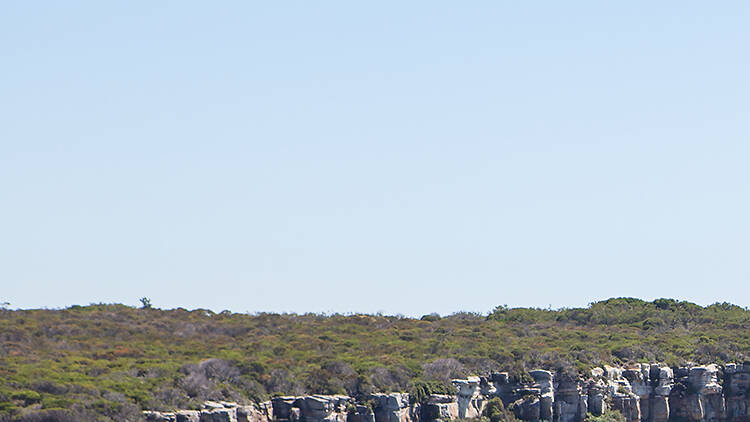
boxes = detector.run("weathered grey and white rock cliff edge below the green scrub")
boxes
[144,362,750,422]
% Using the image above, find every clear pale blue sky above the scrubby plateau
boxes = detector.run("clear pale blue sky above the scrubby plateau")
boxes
[0,0,750,316]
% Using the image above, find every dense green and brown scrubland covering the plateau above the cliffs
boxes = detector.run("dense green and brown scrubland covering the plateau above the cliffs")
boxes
[0,298,750,421]
